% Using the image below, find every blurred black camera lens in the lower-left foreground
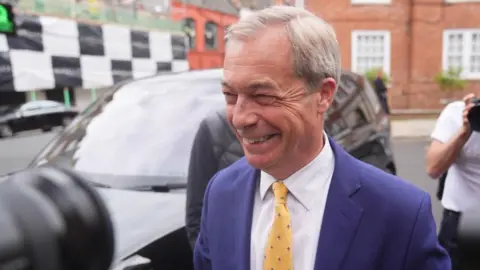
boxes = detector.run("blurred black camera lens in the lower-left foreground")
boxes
[0,167,114,270]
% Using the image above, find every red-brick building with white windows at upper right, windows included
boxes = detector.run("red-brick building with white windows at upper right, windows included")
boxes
[305,0,480,111]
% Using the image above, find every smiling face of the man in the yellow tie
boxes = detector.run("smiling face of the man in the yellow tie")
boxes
[223,27,335,177]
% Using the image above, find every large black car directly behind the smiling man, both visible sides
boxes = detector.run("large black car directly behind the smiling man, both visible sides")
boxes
[19,70,395,270]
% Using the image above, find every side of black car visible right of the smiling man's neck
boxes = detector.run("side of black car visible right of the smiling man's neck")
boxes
[325,70,397,174]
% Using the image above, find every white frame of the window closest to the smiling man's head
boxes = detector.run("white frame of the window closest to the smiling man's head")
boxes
[351,30,392,76]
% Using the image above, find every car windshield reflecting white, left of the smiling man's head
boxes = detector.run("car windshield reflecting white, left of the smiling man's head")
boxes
[31,73,224,190]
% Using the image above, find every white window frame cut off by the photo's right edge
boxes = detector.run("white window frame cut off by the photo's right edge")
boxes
[442,28,480,80]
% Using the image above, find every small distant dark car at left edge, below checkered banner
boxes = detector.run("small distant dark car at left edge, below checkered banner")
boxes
[0,100,78,138]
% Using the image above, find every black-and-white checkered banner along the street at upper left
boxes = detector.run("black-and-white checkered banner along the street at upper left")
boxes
[0,14,189,92]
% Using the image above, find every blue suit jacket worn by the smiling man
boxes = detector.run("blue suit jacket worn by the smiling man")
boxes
[194,138,451,270]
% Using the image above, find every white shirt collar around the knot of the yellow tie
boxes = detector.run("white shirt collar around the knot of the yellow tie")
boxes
[259,133,334,211]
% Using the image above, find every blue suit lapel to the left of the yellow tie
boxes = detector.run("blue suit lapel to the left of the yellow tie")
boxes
[232,158,259,270]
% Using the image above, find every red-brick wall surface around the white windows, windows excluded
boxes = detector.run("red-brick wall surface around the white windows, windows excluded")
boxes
[306,0,480,109]
